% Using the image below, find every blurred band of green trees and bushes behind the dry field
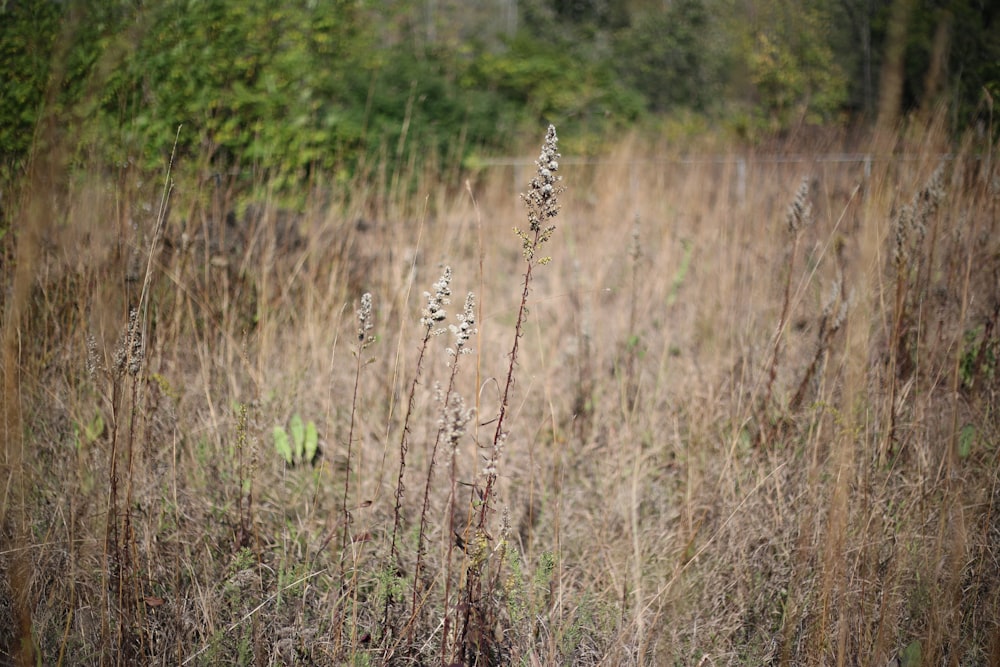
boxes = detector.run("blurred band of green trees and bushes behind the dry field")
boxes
[0,0,1000,188]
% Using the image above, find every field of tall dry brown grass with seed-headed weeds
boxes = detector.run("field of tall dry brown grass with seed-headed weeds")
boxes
[0,117,1000,667]
